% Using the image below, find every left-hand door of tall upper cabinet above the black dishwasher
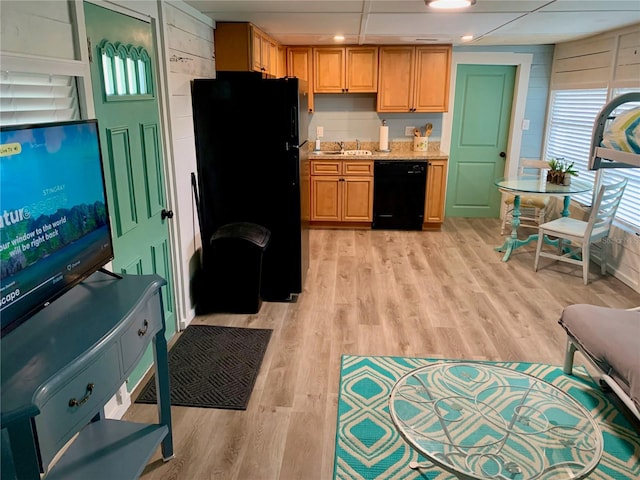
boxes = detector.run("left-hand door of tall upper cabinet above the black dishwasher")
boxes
[377,47,415,112]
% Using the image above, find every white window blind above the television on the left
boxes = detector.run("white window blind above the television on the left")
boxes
[0,71,80,125]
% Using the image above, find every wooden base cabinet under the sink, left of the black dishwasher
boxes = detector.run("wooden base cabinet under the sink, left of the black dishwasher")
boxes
[311,160,373,223]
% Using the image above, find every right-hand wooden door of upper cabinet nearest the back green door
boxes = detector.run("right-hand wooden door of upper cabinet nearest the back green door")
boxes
[413,47,451,112]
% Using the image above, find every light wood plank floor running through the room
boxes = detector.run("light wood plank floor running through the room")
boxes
[130,218,640,480]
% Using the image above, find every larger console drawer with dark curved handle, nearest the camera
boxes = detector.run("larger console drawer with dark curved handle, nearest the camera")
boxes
[35,342,120,466]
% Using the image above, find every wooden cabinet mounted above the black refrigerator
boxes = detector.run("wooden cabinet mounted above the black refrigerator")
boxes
[214,22,278,77]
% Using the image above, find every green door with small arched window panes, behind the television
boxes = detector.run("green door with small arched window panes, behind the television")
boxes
[84,3,176,390]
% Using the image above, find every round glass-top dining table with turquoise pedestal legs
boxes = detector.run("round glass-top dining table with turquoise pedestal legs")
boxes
[494,175,593,262]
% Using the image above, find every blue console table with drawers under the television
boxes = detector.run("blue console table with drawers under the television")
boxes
[0,272,173,480]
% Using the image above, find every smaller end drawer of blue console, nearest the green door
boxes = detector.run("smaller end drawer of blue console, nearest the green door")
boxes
[121,293,162,376]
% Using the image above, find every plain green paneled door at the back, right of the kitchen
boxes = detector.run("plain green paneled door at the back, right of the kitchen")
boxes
[445,65,516,218]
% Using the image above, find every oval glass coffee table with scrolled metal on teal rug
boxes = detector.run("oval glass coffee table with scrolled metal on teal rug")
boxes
[389,362,603,480]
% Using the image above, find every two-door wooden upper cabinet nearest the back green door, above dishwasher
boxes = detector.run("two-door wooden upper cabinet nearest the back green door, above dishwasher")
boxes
[377,45,451,112]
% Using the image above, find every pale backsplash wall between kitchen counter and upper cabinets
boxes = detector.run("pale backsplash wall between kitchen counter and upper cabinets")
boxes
[309,93,442,145]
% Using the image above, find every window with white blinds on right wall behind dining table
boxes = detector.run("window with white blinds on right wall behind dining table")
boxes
[545,88,640,230]
